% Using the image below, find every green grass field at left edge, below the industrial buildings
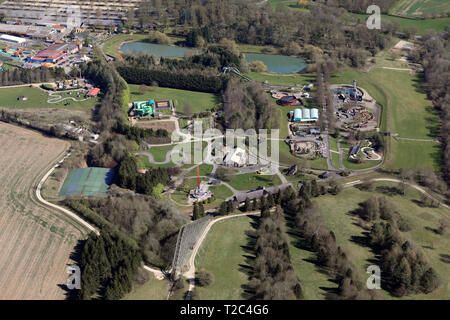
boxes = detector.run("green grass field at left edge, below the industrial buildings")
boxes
[0,87,99,111]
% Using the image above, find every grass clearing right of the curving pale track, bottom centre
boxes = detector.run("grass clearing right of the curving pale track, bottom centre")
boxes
[195,217,253,300]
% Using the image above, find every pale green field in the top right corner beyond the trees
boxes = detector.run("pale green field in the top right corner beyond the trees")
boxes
[389,0,450,18]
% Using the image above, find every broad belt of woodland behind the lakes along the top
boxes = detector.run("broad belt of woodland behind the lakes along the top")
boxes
[133,0,395,67]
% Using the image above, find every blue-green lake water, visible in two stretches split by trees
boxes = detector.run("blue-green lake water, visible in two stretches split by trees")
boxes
[120,41,307,74]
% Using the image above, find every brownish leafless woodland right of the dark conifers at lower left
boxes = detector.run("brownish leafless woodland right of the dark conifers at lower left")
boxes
[67,194,186,269]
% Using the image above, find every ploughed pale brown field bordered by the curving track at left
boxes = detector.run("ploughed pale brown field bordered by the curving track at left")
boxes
[0,122,84,299]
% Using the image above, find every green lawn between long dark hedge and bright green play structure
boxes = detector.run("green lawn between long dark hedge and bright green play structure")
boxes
[130,85,221,114]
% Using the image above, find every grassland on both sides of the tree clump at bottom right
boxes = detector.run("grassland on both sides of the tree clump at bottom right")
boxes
[317,183,450,299]
